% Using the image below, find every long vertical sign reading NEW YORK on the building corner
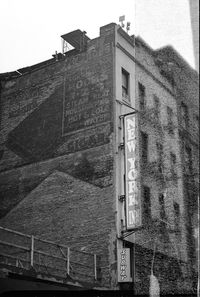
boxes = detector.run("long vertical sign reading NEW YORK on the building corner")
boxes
[124,114,141,230]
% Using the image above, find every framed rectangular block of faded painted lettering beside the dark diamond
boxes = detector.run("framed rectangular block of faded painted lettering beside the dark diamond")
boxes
[63,59,112,135]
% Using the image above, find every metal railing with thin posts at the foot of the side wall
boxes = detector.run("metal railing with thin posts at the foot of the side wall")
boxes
[0,226,100,282]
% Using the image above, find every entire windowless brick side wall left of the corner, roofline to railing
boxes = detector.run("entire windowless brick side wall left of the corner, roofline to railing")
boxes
[0,24,116,287]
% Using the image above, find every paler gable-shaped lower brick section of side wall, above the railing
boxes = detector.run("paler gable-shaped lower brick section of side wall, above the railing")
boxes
[0,165,115,285]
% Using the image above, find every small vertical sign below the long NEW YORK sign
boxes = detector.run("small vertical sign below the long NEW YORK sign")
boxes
[117,249,131,283]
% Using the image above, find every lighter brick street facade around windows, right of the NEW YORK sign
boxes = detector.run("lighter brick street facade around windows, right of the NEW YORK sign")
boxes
[136,46,186,260]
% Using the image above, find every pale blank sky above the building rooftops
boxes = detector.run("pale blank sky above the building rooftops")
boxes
[0,0,194,73]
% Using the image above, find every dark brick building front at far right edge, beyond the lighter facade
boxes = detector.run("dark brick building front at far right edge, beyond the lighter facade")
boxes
[155,46,199,270]
